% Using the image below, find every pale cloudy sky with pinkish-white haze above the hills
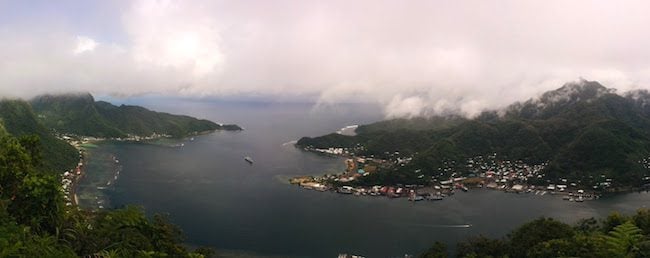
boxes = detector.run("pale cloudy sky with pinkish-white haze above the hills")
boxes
[0,0,650,116]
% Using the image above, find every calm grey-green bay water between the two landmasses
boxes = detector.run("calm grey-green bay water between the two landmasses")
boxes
[80,101,650,257]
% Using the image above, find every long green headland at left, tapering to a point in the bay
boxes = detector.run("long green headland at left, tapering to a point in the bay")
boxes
[31,93,241,137]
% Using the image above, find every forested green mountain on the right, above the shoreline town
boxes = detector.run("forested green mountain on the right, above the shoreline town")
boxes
[297,80,650,186]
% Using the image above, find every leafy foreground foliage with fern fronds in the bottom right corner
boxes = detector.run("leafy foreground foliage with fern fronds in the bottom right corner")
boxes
[420,209,650,258]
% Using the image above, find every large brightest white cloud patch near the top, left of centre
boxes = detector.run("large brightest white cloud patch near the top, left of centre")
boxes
[124,1,224,77]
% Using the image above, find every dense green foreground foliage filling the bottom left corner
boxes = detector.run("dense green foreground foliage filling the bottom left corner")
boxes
[0,126,210,257]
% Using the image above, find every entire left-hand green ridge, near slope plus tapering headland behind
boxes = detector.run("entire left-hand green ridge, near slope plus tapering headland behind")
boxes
[0,93,241,173]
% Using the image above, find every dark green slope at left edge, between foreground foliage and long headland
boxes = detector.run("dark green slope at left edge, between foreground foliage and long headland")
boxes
[0,100,79,172]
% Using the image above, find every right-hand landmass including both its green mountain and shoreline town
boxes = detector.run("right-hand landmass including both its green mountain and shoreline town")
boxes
[294,80,650,197]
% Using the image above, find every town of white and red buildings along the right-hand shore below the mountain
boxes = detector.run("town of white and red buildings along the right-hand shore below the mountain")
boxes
[289,148,647,202]
